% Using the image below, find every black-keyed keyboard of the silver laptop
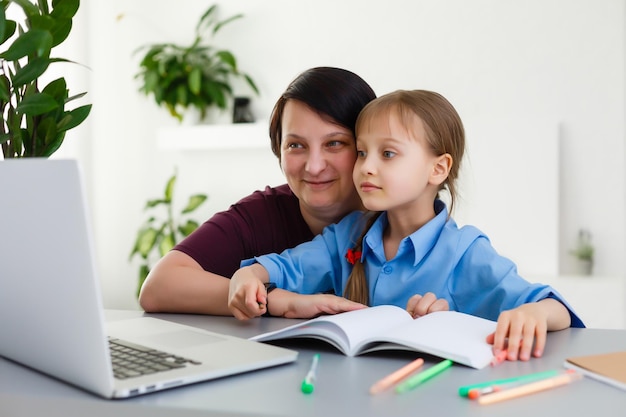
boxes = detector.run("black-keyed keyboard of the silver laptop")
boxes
[109,337,200,379]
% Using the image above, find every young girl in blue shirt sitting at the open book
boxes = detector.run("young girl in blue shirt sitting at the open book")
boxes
[229,90,584,360]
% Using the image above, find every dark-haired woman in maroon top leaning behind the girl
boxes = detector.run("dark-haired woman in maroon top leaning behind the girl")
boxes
[139,67,376,315]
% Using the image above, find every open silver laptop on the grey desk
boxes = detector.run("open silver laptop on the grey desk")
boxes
[0,158,298,398]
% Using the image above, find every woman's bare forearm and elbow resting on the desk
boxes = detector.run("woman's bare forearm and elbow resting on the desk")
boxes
[139,250,232,316]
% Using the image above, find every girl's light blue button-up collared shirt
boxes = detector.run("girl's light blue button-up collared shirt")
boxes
[242,200,584,327]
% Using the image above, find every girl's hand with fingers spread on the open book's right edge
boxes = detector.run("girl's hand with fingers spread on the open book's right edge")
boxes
[487,298,571,361]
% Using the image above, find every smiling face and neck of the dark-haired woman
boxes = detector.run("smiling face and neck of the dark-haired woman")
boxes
[281,100,362,226]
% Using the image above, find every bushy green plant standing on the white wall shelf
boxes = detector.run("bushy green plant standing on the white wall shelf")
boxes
[135,5,259,121]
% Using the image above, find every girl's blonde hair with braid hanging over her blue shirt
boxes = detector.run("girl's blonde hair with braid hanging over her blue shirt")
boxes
[344,90,465,304]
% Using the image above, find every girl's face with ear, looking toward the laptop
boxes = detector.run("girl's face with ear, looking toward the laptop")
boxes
[353,111,449,221]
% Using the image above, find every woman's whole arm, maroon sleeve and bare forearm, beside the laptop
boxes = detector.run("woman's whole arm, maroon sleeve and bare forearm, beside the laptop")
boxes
[139,185,313,315]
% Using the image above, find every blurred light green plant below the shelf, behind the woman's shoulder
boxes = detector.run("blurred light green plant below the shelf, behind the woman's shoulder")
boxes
[129,172,207,295]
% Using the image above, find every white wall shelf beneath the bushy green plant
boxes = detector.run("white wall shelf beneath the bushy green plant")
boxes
[157,122,270,151]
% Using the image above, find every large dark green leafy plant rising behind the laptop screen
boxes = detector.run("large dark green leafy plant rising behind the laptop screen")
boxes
[0,0,91,158]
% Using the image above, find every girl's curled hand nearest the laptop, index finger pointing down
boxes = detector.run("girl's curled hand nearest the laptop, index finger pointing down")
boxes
[228,264,269,320]
